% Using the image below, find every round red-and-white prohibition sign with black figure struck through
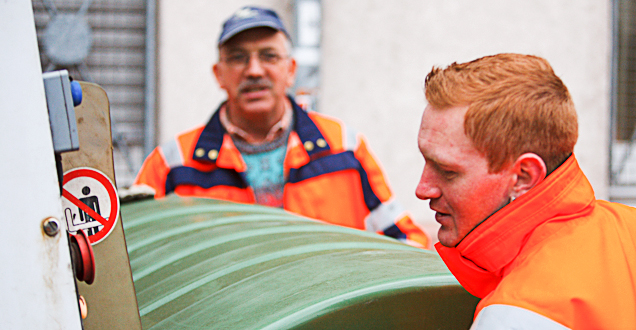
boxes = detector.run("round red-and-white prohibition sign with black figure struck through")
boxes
[62,167,119,245]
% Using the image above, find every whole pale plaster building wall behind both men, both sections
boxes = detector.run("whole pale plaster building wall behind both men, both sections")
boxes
[158,0,611,238]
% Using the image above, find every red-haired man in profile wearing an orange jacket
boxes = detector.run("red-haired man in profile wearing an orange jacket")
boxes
[416,54,636,329]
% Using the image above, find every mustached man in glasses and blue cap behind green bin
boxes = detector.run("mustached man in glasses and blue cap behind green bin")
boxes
[135,7,429,247]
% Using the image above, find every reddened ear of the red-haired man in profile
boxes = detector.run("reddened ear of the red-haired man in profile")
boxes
[511,152,548,198]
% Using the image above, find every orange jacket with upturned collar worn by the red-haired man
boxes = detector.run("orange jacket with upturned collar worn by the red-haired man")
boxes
[436,156,636,329]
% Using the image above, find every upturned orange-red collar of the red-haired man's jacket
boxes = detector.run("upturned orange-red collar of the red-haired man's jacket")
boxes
[435,155,595,298]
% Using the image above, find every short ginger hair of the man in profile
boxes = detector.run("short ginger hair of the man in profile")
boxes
[425,54,578,173]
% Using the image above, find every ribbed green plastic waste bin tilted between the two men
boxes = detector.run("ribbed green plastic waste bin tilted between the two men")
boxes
[122,196,478,330]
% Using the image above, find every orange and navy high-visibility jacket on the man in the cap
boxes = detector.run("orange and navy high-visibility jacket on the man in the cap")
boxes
[134,98,429,247]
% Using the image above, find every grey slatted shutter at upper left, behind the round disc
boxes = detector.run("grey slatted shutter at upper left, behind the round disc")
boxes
[33,0,146,188]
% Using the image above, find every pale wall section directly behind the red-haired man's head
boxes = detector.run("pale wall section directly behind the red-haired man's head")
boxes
[320,0,611,237]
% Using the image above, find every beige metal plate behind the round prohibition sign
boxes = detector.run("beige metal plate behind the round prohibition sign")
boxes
[62,82,141,330]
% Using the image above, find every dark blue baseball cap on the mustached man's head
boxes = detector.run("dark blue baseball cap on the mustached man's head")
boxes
[219,6,291,46]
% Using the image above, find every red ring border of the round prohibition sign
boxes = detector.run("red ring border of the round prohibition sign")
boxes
[62,167,119,244]
